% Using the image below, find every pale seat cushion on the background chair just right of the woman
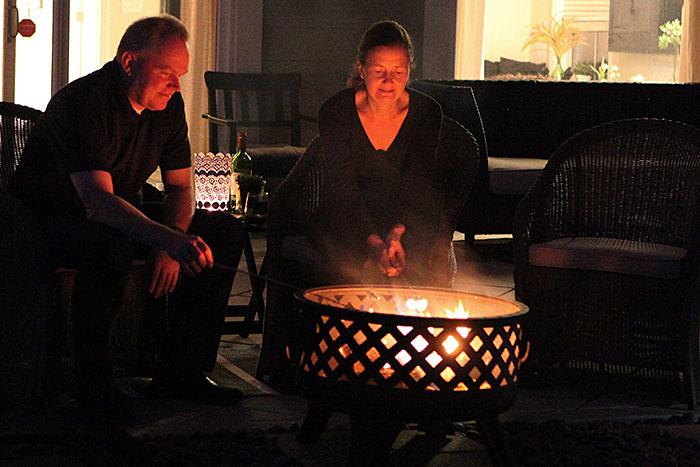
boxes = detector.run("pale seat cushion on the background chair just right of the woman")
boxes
[488,157,547,195]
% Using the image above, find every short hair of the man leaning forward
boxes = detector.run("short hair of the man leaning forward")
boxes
[117,15,189,57]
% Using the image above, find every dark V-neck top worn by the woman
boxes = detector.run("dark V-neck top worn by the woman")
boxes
[314,89,442,284]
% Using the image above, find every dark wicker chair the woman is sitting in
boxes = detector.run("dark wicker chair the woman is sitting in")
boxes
[257,117,479,393]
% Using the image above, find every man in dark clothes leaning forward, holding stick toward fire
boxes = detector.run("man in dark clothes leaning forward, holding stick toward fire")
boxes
[10,16,243,405]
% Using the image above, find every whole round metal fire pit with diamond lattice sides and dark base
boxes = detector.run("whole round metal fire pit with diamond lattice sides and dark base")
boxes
[297,285,527,464]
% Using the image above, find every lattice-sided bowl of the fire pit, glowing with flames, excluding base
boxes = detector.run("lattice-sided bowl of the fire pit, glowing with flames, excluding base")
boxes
[301,286,527,392]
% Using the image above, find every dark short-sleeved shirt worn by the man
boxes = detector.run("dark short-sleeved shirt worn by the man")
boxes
[9,61,191,216]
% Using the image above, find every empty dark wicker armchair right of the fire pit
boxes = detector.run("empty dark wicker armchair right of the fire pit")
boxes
[513,119,700,407]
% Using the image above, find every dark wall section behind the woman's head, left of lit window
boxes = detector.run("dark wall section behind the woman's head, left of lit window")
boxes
[262,0,430,142]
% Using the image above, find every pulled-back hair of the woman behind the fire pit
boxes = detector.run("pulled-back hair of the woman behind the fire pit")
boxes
[347,20,414,88]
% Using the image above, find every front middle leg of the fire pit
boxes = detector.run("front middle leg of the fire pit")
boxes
[348,415,403,467]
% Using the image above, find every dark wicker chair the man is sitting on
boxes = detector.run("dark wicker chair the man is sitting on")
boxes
[0,102,170,408]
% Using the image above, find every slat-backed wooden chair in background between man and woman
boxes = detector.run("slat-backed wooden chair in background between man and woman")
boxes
[202,71,315,197]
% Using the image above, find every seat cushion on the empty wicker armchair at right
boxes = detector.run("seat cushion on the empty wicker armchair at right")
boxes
[528,237,687,279]
